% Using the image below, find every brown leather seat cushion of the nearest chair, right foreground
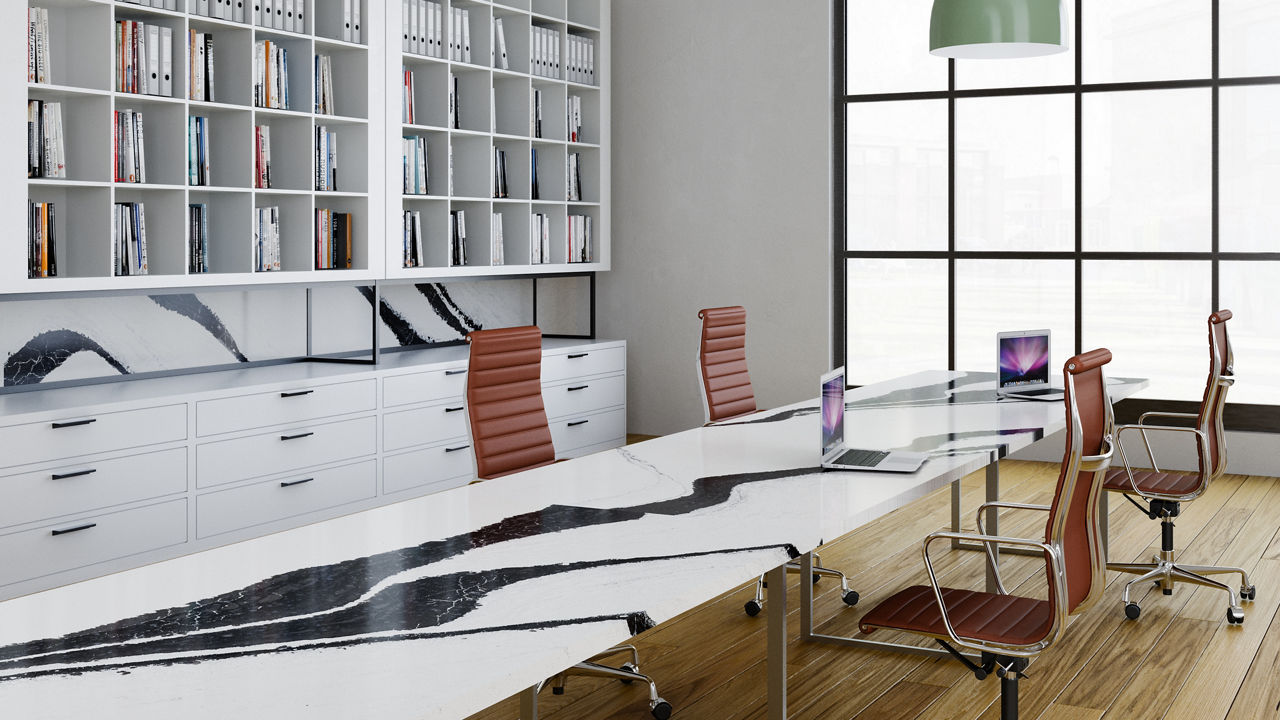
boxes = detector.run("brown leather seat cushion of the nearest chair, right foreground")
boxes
[859,585,1053,646]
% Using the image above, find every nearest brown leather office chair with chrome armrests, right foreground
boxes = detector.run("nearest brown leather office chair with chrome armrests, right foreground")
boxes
[859,350,1114,720]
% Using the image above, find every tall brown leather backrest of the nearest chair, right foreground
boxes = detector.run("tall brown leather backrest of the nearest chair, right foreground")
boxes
[1044,350,1115,614]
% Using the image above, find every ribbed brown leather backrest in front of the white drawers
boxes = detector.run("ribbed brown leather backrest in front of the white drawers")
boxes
[467,325,556,478]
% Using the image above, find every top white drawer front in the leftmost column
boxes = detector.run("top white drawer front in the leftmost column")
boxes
[0,404,187,466]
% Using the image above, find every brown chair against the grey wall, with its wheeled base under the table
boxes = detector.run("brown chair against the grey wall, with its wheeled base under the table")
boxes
[698,305,858,618]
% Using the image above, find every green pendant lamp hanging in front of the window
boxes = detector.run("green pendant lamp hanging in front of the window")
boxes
[929,0,1068,59]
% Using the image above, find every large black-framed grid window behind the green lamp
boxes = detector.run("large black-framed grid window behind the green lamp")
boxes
[833,0,1280,422]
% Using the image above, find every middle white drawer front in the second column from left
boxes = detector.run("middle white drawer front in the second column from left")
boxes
[196,416,378,488]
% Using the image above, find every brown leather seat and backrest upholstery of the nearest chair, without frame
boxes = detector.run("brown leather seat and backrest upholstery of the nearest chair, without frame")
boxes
[859,350,1111,646]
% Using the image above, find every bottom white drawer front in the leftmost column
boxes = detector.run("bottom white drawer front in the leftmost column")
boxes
[0,498,187,585]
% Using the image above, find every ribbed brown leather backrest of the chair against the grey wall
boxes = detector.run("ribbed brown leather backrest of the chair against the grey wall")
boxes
[698,305,755,423]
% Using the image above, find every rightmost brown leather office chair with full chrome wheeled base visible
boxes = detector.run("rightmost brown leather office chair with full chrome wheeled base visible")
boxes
[1103,310,1257,624]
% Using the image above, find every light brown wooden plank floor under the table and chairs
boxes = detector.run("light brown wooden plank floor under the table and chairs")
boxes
[472,460,1280,720]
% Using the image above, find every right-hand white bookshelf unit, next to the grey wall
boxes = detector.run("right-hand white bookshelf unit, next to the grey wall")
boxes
[384,0,611,279]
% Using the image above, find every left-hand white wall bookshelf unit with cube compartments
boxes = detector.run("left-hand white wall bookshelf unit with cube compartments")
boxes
[0,0,388,293]
